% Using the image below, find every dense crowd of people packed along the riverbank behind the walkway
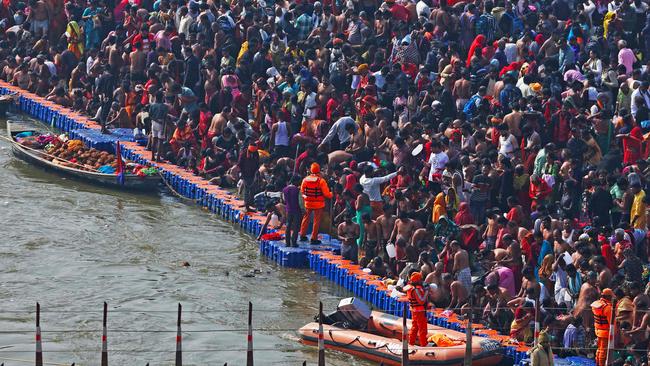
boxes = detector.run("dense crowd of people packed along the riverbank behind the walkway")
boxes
[0,0,650,364]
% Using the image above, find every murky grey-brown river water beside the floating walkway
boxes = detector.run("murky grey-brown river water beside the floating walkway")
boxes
[0,113,370,366]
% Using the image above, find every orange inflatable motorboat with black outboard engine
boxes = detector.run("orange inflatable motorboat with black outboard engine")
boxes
[299,311,504,366]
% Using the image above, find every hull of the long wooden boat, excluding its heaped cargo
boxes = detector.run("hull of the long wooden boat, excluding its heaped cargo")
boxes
[7,121,160,191]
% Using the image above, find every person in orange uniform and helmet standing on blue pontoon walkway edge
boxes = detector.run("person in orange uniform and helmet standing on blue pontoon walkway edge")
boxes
[300,163,332,244]
